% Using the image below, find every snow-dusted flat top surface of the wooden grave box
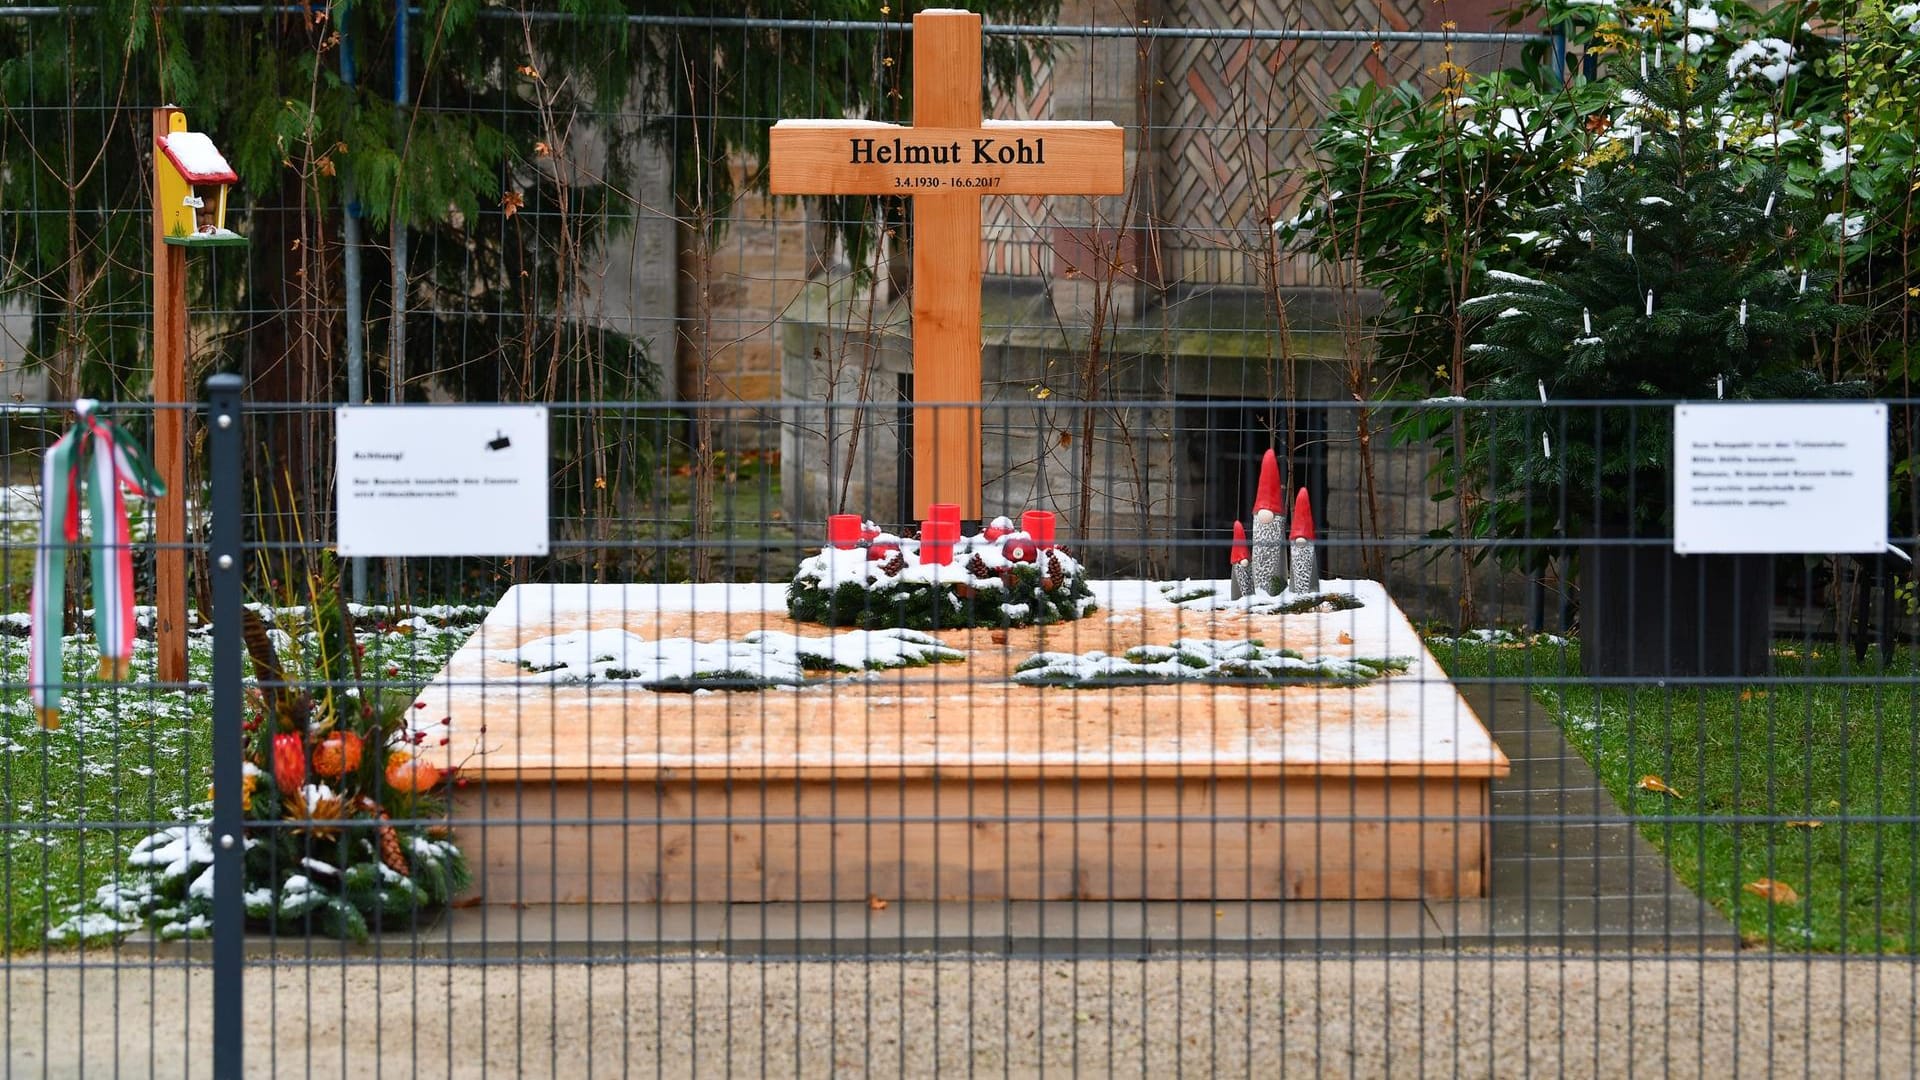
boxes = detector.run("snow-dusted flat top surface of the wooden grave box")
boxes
[417,580,1507,780]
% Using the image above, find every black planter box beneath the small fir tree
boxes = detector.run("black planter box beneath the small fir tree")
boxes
[1580,542,1774,678]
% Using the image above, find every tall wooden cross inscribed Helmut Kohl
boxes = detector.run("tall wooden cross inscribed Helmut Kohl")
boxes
[768,10,1125,521]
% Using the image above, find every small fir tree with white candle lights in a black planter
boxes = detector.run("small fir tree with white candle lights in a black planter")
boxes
[1463,61,1864,536]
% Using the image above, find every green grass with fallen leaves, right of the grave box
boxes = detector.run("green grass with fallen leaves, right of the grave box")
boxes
[1432,630,1920,953]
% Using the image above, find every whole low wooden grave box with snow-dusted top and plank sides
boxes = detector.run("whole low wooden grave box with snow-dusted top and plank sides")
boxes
[420,580,1507,903]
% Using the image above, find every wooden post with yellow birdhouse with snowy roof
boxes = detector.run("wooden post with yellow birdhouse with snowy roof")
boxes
[154,106,246,684]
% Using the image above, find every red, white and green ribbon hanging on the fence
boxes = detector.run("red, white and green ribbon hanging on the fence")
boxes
[27,398,167,728]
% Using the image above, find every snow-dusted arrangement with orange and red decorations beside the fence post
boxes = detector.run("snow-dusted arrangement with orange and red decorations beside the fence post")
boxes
[92,559,470,940]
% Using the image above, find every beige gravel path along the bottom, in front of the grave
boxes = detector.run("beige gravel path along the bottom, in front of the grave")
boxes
[0,953,1920,1076]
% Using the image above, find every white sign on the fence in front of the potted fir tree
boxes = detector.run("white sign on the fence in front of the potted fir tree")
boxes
[1674,402,1887,555]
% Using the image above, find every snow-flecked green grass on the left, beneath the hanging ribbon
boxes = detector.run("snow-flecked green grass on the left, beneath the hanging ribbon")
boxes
[0,611,468,951]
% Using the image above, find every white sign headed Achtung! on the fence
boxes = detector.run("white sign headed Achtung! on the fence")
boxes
[334,405,549,555]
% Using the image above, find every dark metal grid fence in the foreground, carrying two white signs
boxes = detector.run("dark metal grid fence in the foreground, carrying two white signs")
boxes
[4,384,1920,1074]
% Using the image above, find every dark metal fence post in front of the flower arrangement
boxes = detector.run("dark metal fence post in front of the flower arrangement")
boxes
[207,375,246,1078]
